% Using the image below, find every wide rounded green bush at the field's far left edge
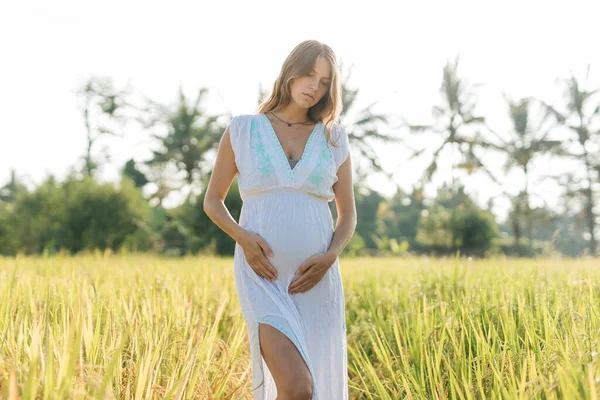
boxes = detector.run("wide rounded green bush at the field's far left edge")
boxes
[0,178,151,254]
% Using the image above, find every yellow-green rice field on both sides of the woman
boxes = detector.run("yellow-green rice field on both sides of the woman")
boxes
[0,253,600,400]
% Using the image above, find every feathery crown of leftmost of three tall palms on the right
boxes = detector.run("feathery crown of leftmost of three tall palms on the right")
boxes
[405,56,498,187]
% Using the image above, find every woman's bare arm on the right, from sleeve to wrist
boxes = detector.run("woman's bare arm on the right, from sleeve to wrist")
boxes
[327,153,356,258]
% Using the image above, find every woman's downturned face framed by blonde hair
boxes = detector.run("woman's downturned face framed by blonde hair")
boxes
[292,57,331,108]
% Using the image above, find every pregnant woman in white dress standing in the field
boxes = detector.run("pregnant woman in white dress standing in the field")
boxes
[204,40,356,400]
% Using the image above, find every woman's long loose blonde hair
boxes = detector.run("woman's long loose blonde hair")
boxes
[257,40,343,147]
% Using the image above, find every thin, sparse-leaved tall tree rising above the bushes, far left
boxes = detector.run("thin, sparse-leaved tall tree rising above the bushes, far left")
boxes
[77,77,130,176]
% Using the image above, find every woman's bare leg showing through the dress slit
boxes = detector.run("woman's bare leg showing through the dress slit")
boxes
[258,323,313,400]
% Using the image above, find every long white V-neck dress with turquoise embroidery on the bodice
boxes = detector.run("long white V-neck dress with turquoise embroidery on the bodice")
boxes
[229,114,348,400]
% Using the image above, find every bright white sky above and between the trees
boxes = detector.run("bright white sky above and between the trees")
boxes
[0,0,600,219]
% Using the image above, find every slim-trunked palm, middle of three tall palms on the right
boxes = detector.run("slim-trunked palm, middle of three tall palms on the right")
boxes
[487,94,564,255]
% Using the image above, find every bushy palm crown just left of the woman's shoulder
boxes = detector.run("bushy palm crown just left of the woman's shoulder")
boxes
[141,87,225,200]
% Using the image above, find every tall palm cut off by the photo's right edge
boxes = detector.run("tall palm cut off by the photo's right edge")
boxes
[542,65,600,255]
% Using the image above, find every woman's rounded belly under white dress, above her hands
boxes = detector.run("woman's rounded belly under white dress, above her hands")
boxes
[240,188,333,283]
